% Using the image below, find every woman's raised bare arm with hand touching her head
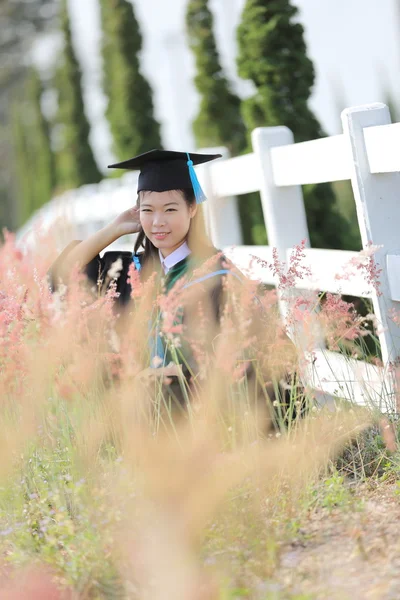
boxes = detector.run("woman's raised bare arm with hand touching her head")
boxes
[52,208,140,283]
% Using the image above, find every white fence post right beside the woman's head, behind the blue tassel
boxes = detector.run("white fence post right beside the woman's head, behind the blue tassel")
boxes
[197,147,243,250]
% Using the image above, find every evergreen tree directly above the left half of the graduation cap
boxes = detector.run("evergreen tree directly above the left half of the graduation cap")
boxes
[100,0,162,159]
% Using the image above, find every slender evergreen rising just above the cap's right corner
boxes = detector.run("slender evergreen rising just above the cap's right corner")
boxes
[186,0,246,155]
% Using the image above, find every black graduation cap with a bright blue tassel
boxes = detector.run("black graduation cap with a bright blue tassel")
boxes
[108,150,222,204]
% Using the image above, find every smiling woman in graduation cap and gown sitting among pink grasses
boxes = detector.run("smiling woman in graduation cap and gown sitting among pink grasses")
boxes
[47,150,296,422]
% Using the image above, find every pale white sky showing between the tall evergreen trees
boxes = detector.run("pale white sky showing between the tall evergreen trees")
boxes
[35,0,400,172]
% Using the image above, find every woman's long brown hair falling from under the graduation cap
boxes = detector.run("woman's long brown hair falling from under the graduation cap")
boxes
[134,188,218,268]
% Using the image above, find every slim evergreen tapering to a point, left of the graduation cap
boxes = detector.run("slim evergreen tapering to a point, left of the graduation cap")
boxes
[55,0,102,189]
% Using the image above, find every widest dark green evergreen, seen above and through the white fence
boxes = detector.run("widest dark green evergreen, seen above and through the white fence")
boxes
[237,0,349,248]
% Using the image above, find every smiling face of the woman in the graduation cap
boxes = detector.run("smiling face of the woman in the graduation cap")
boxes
[140,190,197,258]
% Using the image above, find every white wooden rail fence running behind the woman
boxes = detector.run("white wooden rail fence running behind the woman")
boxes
[21,104,400,411]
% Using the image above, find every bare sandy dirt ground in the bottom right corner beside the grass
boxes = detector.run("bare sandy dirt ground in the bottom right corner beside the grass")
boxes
[278,484,400,600]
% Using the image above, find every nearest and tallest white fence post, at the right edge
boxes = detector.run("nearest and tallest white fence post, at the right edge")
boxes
[342,103,400,365]
